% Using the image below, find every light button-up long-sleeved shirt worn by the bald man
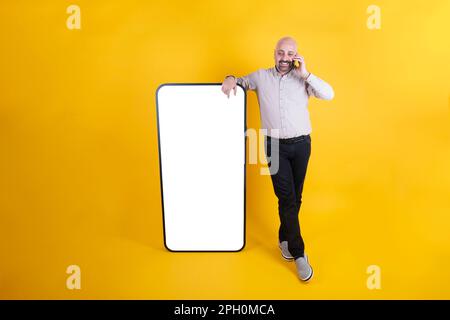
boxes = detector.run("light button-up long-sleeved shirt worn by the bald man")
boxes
[237,67,334,139]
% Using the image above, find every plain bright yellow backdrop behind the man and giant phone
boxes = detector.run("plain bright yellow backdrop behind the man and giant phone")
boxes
[0,0,450,299]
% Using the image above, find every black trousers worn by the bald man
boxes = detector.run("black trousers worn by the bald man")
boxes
[265,135,311,259]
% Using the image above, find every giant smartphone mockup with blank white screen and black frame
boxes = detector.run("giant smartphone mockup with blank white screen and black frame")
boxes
[157,84,245,251]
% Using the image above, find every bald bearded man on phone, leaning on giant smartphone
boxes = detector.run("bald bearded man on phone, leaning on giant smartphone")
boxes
[222,37,334,281]
